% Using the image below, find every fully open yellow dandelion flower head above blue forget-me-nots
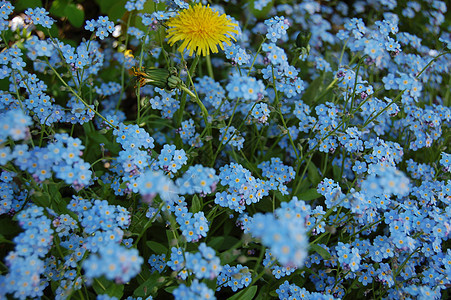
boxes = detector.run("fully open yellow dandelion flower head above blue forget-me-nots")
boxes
[166,3,238,56]
